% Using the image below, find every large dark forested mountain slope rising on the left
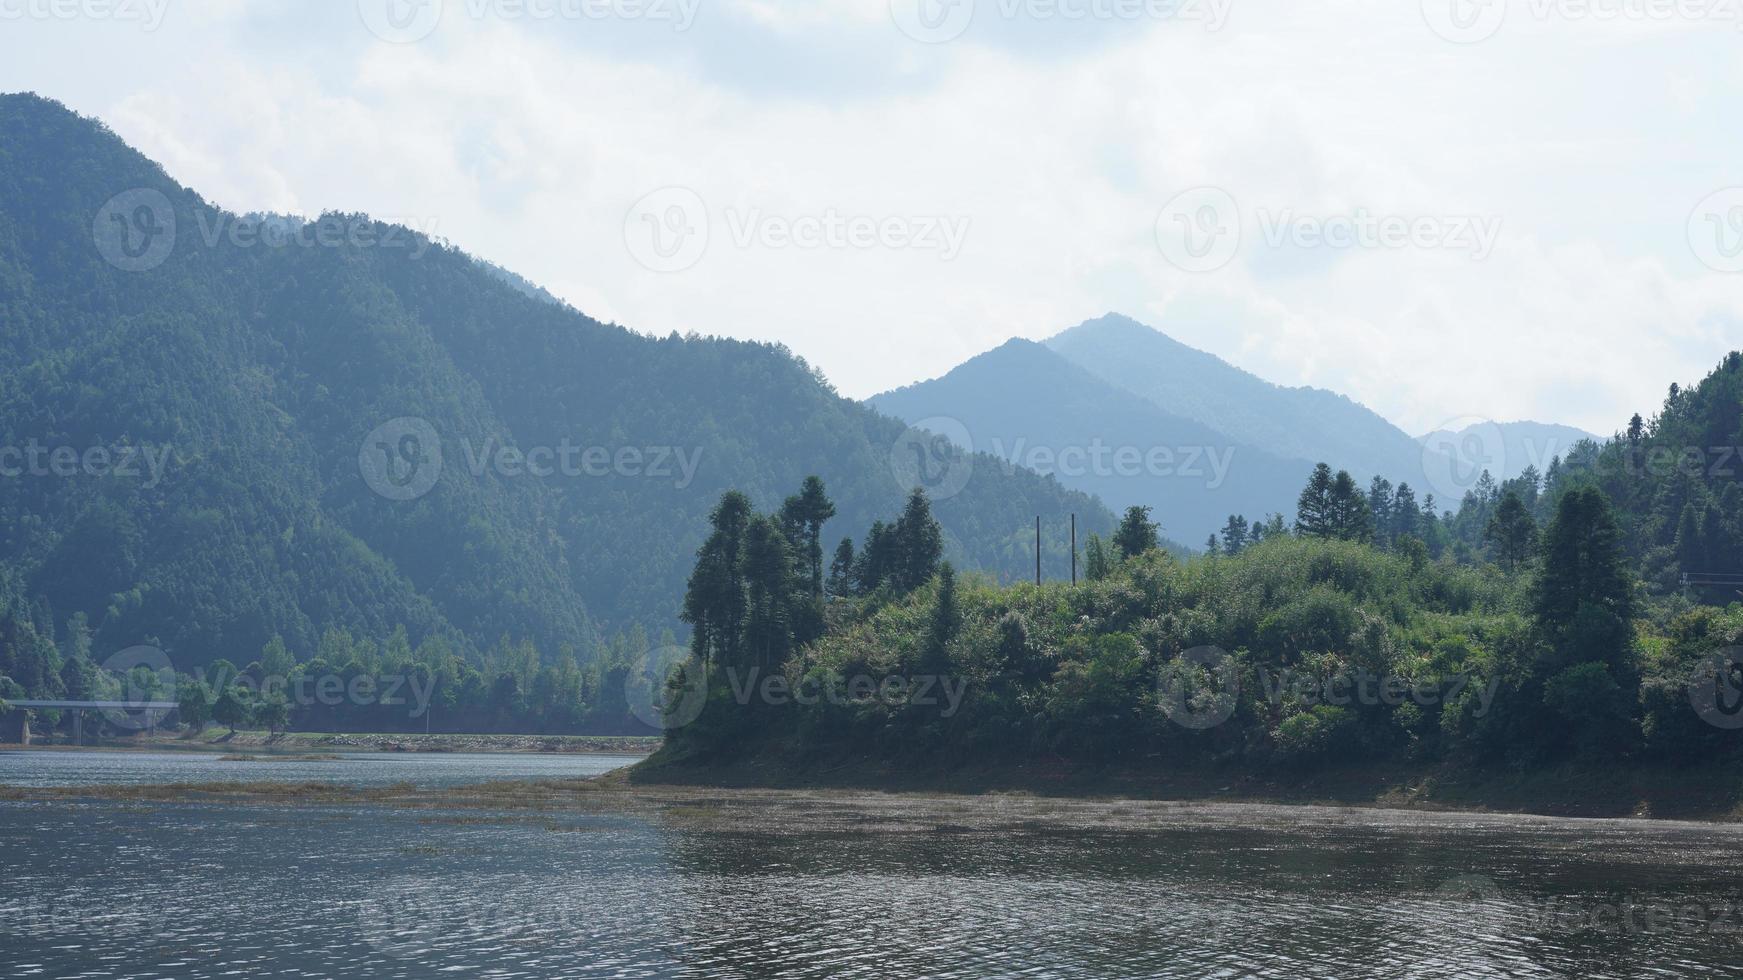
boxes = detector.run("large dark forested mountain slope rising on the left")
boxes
[0,96,1112,668]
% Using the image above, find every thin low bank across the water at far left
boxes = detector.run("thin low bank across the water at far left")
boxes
[0,729,662,755]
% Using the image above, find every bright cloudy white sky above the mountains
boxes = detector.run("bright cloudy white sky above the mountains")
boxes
[0,0,1743,434]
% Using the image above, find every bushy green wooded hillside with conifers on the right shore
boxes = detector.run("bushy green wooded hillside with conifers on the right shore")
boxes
[658,350,1743,777]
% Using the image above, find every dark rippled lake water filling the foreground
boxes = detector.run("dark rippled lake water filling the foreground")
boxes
[0,753,1743,980]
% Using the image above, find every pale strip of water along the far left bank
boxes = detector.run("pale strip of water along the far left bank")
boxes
[0,750,641,788]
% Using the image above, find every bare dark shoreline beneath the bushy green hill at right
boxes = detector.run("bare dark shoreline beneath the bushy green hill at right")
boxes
[627,752,1743,823]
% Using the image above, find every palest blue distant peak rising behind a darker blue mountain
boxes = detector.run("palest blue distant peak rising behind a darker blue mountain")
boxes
[1046,314,1443,483]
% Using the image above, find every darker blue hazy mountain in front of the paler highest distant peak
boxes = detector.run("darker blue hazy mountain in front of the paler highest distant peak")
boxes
[872,340,1312,546]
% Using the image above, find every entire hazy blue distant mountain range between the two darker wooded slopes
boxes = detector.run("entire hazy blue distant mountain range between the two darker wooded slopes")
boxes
[870,314,1586,544]
